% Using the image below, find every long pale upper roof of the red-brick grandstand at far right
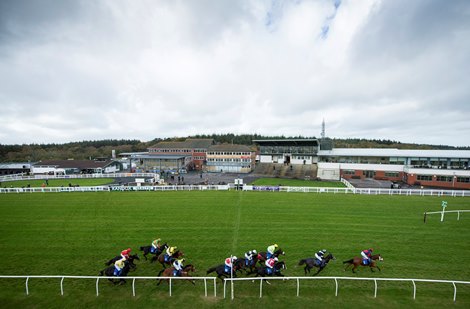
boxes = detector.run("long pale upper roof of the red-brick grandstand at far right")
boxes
[318,148,470,158]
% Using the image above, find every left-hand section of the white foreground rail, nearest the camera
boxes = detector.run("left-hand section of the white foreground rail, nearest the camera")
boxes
[0,275,217,297]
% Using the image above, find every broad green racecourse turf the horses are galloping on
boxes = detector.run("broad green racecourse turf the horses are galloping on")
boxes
[0,191,470,308]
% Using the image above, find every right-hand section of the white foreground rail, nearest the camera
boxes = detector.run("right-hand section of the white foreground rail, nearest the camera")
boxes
[224,277,470,302]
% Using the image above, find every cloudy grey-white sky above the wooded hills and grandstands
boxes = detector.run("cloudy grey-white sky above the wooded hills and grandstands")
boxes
[0,0,470,146]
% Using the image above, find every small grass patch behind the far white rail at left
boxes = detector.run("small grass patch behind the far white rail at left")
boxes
[0,178,114,188]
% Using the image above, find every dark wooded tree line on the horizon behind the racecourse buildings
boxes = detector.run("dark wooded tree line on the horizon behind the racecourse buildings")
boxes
[0,133,470,162]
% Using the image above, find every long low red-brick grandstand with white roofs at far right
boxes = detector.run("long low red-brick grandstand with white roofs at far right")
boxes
[318,148,470,189]
